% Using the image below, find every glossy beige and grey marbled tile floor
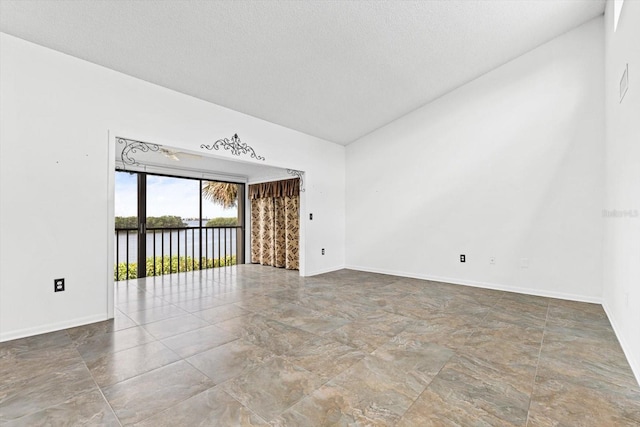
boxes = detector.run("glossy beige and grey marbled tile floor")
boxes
[0,265,640,427]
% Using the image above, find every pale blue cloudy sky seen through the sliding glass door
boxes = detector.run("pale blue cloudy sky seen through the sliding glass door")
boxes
[115,172,237,218]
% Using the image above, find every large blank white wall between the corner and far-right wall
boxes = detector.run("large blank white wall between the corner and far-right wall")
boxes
[346,18,604,301]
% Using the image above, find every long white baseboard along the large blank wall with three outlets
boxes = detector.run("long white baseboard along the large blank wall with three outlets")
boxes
[345,265,602,304]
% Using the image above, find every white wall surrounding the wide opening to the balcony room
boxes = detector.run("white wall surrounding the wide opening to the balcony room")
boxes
[0,34,345,341]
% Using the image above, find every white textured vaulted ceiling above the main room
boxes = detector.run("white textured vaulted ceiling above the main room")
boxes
[0,0,605,144]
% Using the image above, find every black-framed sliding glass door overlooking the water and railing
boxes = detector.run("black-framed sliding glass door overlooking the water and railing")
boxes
[114,170,245,281]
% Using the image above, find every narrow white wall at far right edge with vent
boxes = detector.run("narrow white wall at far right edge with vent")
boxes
[603,1,640,382]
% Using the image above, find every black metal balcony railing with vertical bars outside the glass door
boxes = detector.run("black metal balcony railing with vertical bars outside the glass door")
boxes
[114,226,243,281]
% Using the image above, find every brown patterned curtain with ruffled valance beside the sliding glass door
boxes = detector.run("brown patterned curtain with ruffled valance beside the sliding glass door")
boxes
[249,178,300,270]
